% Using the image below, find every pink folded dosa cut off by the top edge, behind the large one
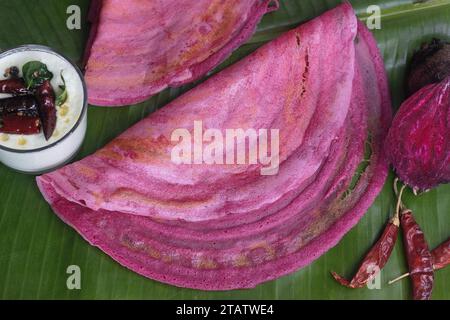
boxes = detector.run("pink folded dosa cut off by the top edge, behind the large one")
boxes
[85,0,278,106]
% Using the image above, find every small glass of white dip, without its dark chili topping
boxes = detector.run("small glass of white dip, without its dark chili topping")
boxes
[0,45,87,173]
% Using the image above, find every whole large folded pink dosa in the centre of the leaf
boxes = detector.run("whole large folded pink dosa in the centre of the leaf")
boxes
[37,4,391,290]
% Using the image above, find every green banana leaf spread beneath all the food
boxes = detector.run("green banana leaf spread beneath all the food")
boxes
[0,0,450,299]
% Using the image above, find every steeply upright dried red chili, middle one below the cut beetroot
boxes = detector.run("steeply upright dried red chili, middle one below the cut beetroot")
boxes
[400,209,434,300]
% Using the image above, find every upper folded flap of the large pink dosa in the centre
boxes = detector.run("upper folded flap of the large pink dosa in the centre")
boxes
[42,2,357,221]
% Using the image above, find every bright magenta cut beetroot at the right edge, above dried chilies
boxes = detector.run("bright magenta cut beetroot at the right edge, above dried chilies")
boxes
[386,77,450,191]
